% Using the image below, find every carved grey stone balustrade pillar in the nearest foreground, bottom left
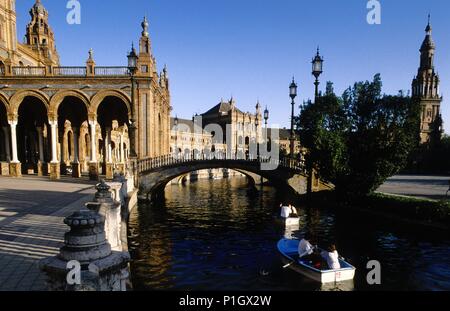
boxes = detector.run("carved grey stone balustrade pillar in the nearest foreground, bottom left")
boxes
[39,210,130,291]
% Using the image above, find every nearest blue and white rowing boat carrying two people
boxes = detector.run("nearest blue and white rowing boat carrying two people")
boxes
[277,239,356,284]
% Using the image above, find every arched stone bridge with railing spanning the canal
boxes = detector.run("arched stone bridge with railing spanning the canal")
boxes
[137,155,308,199]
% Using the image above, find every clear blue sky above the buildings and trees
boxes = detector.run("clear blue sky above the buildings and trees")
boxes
[17,0,450,133]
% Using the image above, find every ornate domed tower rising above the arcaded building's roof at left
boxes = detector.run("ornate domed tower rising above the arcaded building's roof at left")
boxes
[25,0,59,65]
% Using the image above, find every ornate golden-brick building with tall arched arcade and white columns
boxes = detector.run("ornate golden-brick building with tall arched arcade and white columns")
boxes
[0,0,171,179]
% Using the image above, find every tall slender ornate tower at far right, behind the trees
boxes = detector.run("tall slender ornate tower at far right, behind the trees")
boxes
[412,16,442,144]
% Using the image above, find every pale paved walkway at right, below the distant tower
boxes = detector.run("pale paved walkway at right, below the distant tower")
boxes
[378,175,450,200]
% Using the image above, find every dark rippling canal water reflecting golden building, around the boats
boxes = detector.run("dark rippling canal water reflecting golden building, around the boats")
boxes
[129,178,450,291]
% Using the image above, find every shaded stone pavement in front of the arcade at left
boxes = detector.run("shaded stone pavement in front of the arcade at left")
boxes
[0,177,95,291]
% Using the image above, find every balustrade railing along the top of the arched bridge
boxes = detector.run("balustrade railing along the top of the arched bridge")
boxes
[137,153,305,174]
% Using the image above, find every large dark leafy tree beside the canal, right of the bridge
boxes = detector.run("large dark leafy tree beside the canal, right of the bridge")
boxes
[297,75,419,198]
